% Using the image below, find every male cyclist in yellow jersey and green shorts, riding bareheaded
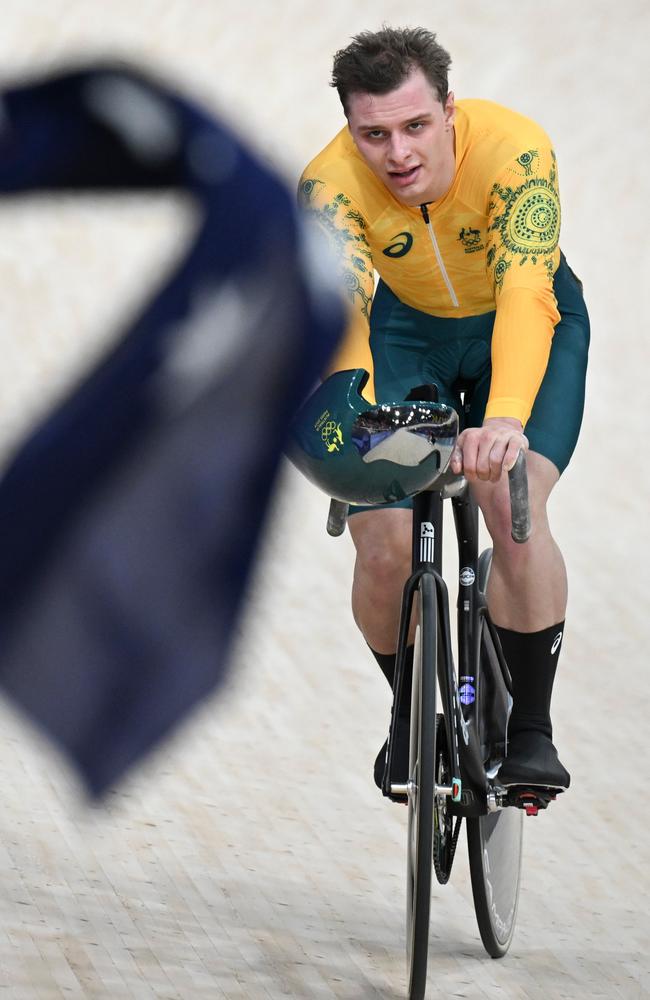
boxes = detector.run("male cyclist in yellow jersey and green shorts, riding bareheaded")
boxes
[300,27,589,788]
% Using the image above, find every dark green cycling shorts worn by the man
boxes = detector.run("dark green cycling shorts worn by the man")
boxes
[350,255,589,513]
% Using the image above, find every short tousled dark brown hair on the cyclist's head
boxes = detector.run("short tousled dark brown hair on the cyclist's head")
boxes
[331,25,451,115]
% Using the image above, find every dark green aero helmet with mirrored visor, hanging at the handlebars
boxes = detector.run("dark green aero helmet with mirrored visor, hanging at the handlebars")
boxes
[287,368,458,505]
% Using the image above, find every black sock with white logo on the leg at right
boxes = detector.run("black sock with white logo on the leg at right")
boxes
[496,622,564,739]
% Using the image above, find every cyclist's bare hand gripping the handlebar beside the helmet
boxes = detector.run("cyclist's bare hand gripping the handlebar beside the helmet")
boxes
[451,417,528,483]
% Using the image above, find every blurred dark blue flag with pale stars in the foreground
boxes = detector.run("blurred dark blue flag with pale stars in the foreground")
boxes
[0,65,344,795]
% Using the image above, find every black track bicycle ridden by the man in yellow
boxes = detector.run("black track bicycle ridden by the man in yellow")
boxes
[327,386,558,1000]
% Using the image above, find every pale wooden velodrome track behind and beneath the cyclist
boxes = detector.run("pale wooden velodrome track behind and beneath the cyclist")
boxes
[0,0,650,1000]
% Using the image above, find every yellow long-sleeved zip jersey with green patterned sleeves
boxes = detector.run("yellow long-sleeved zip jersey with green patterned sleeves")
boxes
[299,100,560,424]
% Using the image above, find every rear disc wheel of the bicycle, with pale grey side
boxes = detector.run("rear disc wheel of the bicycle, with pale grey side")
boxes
[467,552,523,958]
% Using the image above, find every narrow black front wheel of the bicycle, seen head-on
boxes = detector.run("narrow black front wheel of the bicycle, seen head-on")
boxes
[406,574,437,1000]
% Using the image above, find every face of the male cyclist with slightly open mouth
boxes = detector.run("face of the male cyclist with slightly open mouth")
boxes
[348,69,455,205]
